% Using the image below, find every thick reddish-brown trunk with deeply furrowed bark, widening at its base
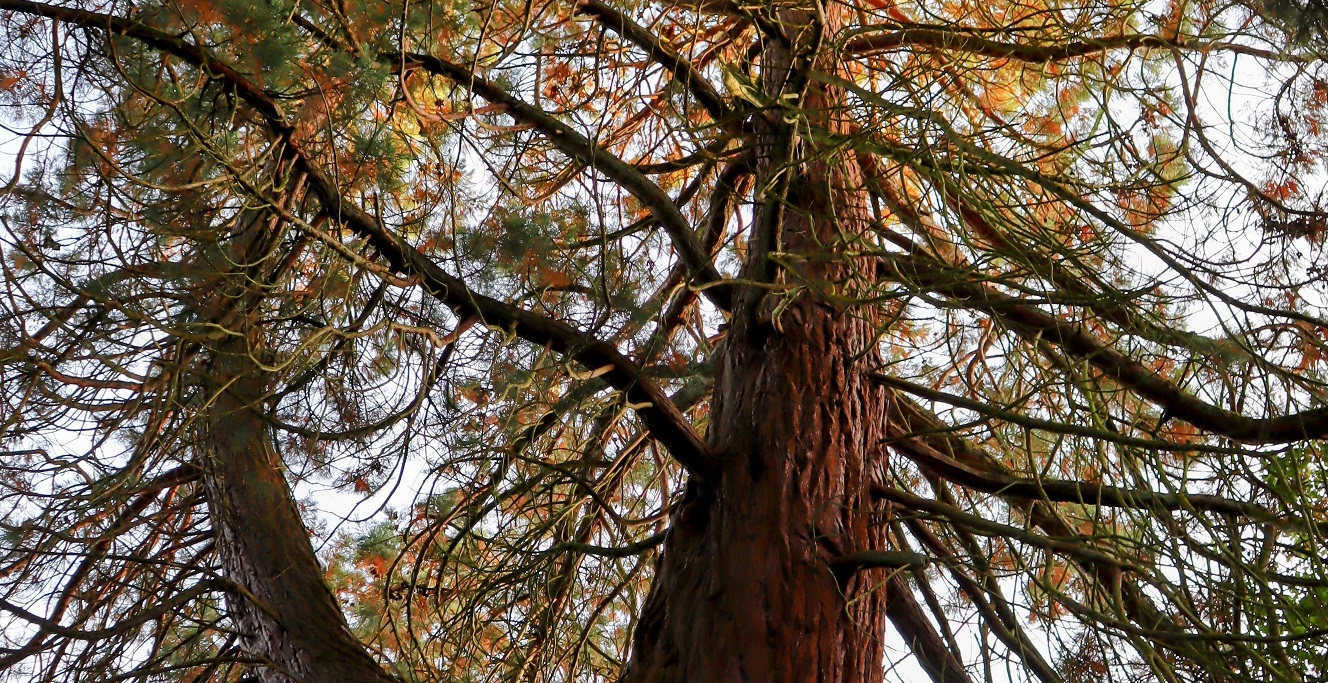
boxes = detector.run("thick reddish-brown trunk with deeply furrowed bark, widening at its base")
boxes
[624,12,887,675]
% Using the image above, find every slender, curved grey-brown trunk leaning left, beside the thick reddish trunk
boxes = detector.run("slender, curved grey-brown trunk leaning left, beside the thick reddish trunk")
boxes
[195,191,394,683]
